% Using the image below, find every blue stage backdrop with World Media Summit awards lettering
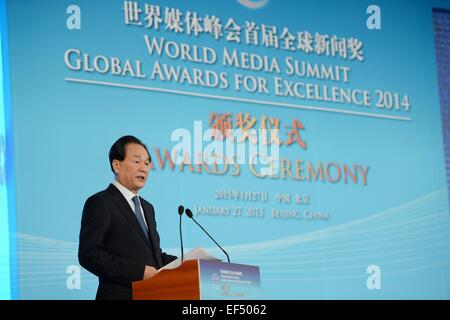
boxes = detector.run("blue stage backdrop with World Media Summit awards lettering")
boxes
[3,0,450,299]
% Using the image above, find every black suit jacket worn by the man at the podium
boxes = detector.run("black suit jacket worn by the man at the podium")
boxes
[78,184,176,299]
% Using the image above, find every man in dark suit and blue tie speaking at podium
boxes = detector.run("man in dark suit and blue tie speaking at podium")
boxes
[78,136,176,299]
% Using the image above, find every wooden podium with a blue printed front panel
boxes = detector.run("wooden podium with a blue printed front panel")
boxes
[132,260,260,300]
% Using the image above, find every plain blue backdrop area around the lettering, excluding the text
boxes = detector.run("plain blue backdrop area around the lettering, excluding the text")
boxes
[3,0,450,299]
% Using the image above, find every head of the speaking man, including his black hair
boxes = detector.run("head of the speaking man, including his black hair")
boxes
[109,136,151,193]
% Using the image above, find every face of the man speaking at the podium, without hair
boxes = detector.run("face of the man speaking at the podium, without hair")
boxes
[113,143,150,193]
